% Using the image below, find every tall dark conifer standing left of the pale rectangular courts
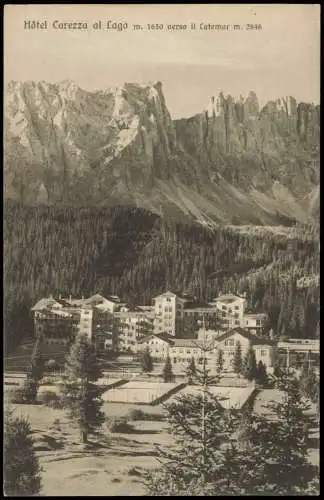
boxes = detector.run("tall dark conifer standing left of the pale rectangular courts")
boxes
[62,335,104,443]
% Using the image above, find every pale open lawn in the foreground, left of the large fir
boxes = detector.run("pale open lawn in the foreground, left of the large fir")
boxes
[7,404,171,496]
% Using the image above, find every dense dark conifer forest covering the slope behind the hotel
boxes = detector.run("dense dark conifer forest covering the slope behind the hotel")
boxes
[4,202,319,350]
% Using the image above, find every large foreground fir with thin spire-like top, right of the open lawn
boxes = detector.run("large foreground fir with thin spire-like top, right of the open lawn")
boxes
[146,340,243,496]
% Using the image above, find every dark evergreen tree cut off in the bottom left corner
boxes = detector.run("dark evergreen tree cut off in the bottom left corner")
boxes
[4,409,41,497]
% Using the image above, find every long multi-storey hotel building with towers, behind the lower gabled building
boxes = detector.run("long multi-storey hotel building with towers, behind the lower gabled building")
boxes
[32,291,266,352]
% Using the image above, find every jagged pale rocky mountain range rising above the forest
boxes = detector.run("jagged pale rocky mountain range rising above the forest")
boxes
[4,81,320,225]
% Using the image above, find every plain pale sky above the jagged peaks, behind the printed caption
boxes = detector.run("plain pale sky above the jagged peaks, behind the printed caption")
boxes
[4,4,320,118]
